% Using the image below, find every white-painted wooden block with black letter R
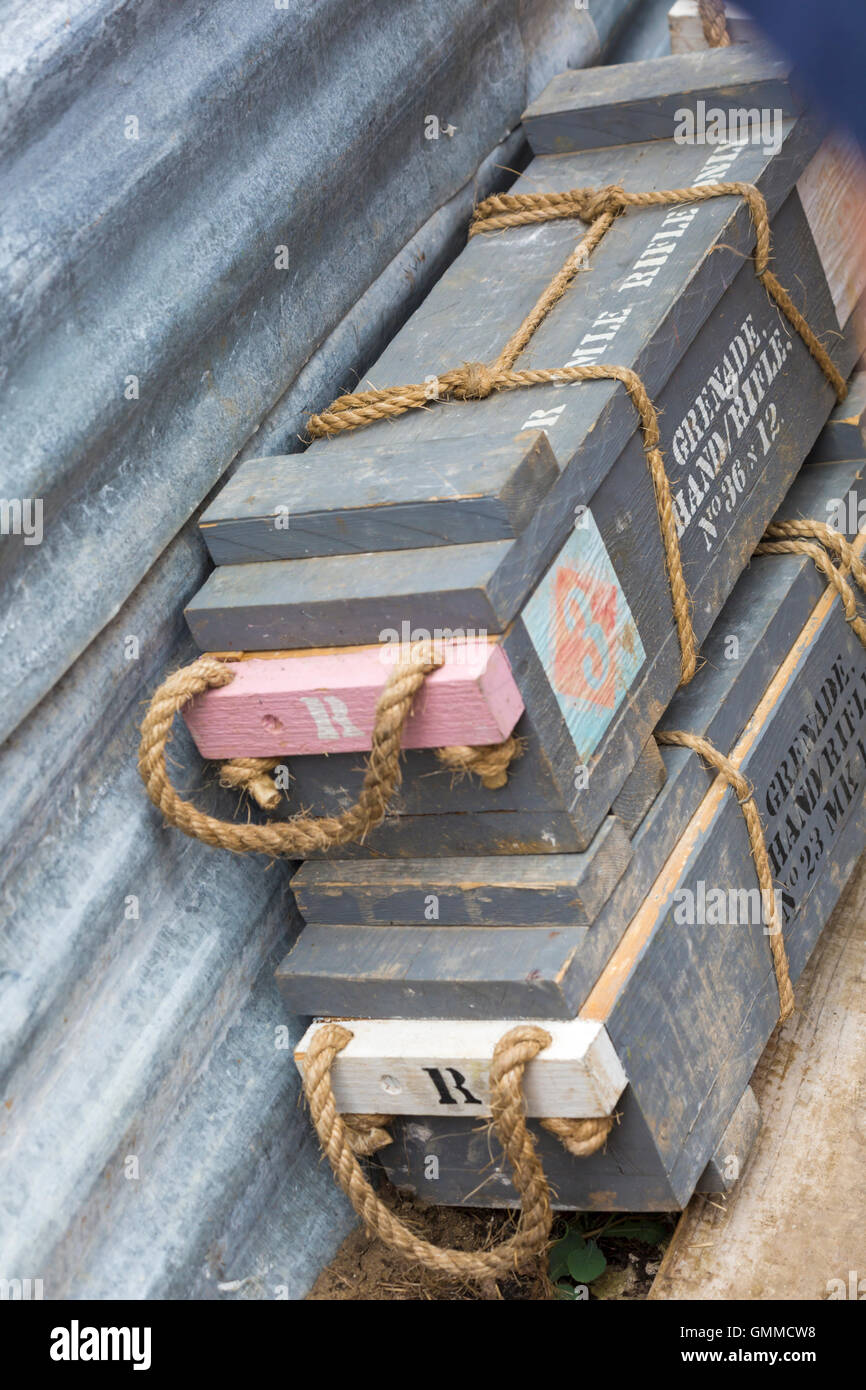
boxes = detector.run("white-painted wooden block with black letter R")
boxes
[295,1019,627,1119]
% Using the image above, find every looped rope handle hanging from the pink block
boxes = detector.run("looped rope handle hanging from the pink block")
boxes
[138,644,507,859]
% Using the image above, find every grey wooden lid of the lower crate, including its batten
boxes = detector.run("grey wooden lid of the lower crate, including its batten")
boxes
[278,439,865,1017]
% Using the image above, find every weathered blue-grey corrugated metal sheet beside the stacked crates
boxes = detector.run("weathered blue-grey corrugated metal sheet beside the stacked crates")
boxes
[0,0,650,1298]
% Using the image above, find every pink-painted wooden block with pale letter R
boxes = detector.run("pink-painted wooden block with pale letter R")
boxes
[183,642,523,759]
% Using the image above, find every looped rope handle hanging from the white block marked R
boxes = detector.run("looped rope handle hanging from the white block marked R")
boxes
[303,1023,553,1280]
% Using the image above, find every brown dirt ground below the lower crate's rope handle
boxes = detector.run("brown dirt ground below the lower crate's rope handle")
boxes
[307,1184,678,1302]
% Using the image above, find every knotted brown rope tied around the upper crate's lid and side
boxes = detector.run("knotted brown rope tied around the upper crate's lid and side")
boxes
[307,182,847,685]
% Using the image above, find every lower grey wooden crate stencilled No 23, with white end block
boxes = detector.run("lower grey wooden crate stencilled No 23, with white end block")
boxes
[286,403,866,1209]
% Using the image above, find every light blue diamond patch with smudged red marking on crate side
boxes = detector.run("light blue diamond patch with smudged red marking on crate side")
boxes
[521,510,646,762]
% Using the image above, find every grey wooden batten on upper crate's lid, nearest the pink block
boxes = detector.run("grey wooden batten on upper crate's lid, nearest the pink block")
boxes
[200,430,559,564]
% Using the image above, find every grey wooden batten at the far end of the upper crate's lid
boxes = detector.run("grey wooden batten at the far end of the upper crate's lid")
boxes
[523,43,803,154]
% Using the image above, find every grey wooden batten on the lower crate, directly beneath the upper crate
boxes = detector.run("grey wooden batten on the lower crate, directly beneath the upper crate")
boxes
[292,816,631,927]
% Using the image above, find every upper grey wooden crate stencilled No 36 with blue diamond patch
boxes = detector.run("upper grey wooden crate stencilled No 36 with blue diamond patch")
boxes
[188,50,856,858]
